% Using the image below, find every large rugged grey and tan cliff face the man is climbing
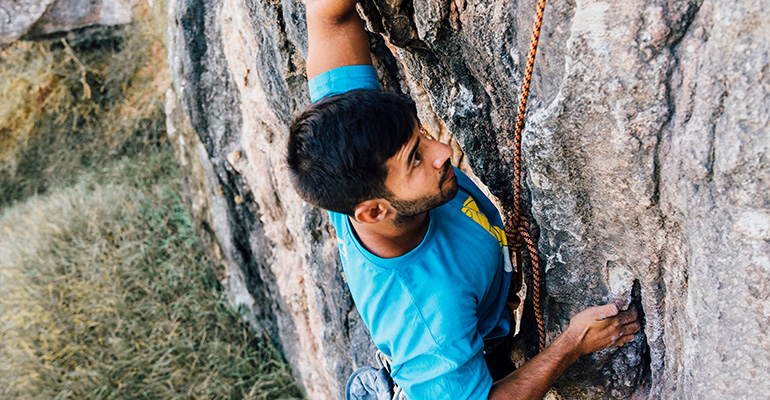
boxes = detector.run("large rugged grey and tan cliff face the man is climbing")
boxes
[167,0,770,399]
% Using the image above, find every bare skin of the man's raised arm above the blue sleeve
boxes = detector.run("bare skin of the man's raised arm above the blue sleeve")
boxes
[305,0,372,80]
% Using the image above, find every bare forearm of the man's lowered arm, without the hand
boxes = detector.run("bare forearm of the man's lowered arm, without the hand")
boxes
[489,334,579,400]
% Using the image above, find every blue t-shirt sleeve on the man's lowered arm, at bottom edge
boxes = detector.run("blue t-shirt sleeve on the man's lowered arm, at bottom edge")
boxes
[395,349,492,400]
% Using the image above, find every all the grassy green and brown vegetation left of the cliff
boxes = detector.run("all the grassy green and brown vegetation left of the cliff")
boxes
[0,2,302,399]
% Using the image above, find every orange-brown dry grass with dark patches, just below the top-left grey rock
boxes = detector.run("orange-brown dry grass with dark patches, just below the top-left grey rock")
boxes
[0,2,168,206]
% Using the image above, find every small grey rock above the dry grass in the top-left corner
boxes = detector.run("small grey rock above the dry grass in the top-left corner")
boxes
[0,0,138,43]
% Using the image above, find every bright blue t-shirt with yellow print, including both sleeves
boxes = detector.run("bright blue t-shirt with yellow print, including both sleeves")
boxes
[309,66,512,400]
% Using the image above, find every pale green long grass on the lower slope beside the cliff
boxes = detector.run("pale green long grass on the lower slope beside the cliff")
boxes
[0,147,301,399]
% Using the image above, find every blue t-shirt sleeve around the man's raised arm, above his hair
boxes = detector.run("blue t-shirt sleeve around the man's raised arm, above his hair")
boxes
[308,65,382,103]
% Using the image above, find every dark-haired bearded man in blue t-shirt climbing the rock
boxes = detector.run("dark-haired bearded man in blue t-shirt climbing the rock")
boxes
[287,0,639,400]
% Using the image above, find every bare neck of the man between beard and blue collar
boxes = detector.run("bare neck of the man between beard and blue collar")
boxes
[350,212,430,258]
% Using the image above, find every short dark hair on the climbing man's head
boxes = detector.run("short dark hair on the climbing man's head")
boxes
[286,90,418,216]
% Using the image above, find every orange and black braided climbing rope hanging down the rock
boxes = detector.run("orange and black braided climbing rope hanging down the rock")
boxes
[505,0,545,351]
